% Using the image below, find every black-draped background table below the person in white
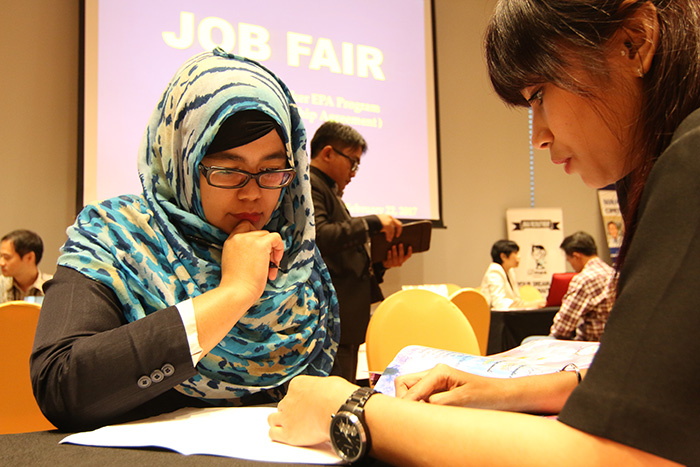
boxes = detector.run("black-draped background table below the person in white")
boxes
[486,306,559,355]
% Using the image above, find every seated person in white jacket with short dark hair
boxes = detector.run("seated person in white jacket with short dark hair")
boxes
[480,240,544,310]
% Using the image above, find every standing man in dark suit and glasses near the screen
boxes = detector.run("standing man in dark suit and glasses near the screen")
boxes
[311,121,413,382]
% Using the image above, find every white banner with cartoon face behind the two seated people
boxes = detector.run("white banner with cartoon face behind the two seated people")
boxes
[506,208,566,297]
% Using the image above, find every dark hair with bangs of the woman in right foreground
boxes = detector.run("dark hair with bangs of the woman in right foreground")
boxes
[486,0,700,267]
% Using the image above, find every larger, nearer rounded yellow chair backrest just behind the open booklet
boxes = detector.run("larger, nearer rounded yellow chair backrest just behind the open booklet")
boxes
[366,289,480,372]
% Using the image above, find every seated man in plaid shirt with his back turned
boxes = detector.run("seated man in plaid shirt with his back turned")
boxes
[549,232,615,341]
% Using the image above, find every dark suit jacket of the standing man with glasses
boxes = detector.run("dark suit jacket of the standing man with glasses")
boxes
[311,167,385,344]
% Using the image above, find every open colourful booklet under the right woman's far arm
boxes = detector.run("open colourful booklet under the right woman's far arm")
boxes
[374,339,599,396]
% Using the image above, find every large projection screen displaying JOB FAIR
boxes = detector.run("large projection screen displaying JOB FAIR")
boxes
[82,0,441,225]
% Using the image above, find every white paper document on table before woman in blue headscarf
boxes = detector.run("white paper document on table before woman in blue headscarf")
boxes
[61,407,341,464]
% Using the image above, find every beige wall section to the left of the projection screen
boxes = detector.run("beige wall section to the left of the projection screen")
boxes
[0,0,79,273]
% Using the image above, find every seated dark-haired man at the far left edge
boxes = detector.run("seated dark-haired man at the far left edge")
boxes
[0,229,52,303]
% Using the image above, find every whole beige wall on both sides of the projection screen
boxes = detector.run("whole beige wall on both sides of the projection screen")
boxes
[0,0,608,293]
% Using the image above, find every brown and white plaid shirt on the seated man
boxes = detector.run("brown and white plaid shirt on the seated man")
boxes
[550,257,615,341]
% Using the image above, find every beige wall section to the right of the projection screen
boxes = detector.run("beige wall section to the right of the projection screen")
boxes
[383,0,609,294]
